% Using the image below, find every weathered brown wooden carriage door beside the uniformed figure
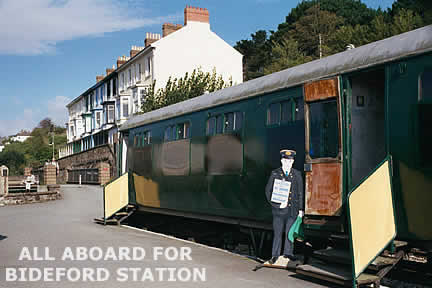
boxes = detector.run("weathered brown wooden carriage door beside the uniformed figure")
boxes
[304,78,343,216]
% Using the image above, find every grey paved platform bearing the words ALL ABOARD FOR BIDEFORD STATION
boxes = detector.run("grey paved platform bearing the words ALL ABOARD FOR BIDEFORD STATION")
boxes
[0,185,326,288]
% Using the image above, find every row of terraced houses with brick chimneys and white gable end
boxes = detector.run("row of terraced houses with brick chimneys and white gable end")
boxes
[59,6,243,182]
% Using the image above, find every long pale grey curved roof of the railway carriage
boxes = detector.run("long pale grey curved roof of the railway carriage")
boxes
[120,25,432,131]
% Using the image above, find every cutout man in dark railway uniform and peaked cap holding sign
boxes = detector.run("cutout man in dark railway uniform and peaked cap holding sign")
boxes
[265,150,304,264]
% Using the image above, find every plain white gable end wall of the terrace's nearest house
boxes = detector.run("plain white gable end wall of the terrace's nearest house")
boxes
[152,22,243,88]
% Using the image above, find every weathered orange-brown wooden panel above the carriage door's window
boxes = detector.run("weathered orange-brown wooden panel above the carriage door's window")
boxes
[304,78,339,101]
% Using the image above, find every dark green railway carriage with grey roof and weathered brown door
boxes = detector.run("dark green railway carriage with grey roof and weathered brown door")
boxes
[114,26,432,254]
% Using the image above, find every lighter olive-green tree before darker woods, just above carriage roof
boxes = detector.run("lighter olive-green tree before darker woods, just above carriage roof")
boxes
[264,38,312,74]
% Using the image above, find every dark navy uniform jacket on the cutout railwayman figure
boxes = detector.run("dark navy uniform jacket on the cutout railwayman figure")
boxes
[265,168,304,217]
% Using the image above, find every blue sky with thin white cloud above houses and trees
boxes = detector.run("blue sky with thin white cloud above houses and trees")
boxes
[0,0,394,136]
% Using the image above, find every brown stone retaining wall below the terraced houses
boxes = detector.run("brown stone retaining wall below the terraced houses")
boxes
[58,144,117,184]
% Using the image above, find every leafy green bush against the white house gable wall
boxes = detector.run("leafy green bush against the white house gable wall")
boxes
[140,68,233,113]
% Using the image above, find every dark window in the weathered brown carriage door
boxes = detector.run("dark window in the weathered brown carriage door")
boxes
[309,99,339,158]
